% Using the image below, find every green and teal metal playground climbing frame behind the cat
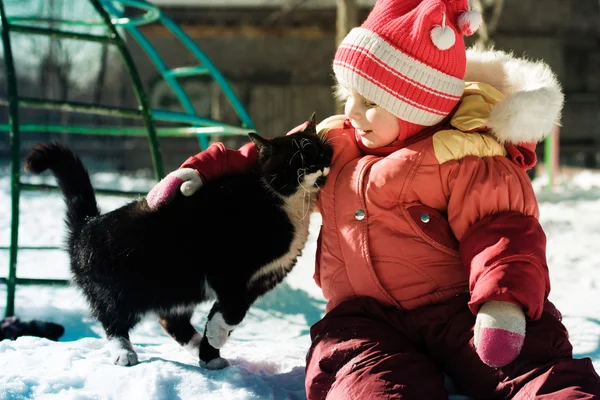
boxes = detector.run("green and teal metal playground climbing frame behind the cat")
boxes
[0,0,254,315]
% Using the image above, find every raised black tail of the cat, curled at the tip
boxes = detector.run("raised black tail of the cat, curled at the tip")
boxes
[25,143,100,234]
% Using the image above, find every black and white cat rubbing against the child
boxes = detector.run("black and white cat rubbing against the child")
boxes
[25,120,333,369]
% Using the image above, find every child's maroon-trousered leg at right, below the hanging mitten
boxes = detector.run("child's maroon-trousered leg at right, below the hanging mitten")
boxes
[421,298,600,400]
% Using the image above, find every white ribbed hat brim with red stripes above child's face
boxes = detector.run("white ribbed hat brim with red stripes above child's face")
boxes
[333,28,464,126]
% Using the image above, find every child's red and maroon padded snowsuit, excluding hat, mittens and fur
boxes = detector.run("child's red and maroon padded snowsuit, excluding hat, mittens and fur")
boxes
[182,61,600,400]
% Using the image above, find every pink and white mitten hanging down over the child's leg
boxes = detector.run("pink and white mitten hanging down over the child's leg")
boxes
[475,301,525,368]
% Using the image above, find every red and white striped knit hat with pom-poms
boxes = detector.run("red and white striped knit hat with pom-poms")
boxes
[333,0,481,138]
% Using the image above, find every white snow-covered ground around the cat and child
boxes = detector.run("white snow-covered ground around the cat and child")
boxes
[0,169,600,400]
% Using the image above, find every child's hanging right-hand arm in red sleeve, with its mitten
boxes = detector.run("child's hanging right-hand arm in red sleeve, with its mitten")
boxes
[442,156,550,367]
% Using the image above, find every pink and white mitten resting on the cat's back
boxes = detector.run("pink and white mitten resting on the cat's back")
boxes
[146,168,202,209]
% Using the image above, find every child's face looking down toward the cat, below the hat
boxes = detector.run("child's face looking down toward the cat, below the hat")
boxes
[344,90,400,149]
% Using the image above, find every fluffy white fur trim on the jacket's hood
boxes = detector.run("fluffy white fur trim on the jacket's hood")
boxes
[465,49,564,144]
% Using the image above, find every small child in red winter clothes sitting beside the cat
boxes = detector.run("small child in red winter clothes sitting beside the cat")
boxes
[149,0,600,400]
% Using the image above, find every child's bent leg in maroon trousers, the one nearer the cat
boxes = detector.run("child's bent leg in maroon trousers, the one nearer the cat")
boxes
[306,298,448,400]
